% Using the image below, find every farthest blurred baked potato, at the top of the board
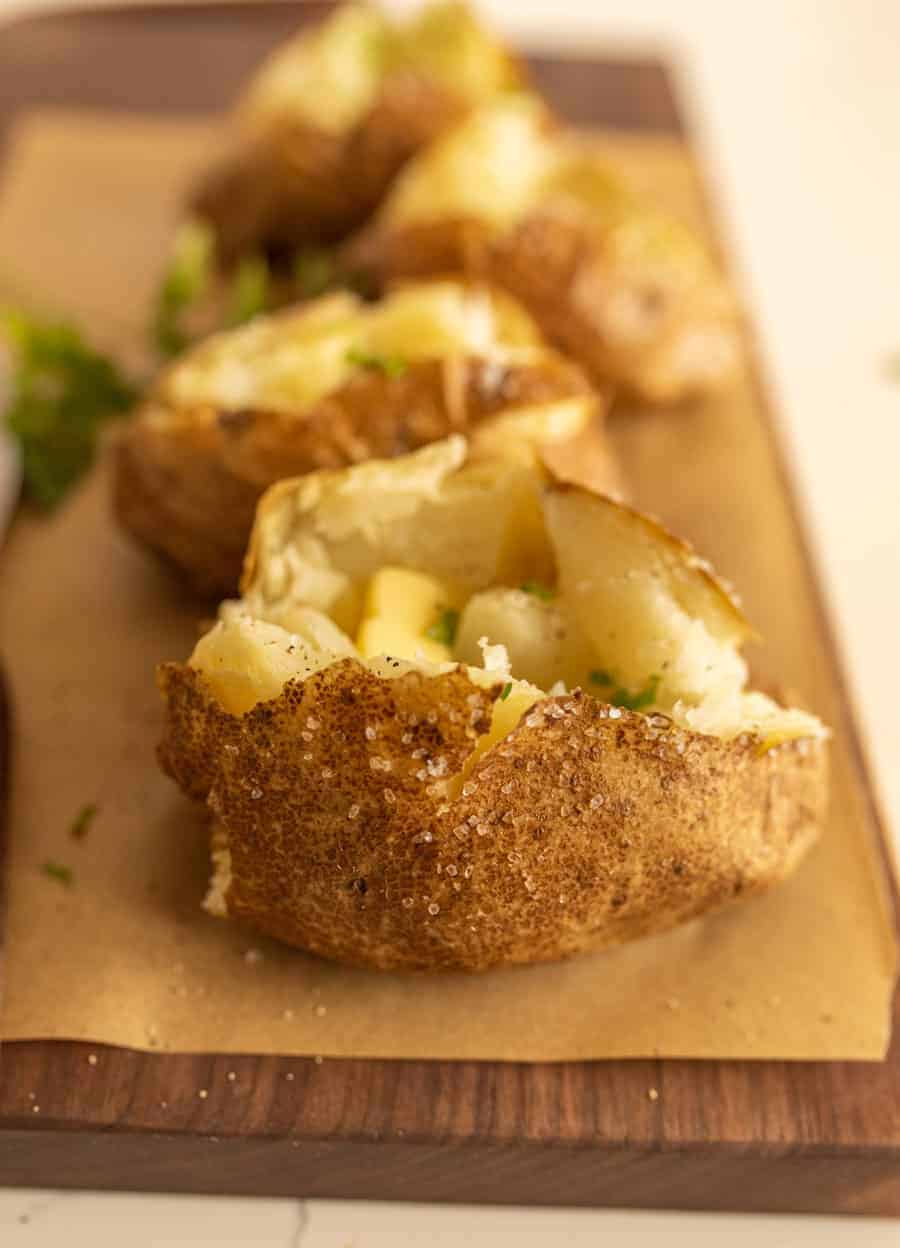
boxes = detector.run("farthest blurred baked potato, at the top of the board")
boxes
[192,2,523,265]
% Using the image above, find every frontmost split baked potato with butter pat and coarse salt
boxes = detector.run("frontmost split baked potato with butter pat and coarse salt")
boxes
[159,436,826,971]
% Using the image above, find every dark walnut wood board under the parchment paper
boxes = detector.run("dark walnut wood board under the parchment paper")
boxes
[0,5,900,1214]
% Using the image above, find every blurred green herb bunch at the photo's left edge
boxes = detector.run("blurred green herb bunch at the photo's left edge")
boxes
[0,312,137,508]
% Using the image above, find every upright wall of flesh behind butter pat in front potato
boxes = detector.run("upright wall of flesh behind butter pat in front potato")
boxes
[246,437,553,634]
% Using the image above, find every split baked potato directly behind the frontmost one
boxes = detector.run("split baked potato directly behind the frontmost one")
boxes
[114,282,604,598]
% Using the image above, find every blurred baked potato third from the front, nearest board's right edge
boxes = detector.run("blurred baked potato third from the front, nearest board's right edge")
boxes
[342,92,739,403]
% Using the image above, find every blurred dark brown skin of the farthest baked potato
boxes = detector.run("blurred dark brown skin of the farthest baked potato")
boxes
[191,72,481,266]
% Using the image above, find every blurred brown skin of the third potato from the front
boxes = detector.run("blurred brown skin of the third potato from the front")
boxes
[341,211,739,403]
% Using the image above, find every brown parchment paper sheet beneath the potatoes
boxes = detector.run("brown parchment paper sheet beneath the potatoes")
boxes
[0,115,895,1061]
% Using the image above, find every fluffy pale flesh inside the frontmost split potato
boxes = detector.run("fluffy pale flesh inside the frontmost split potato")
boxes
[220,438,825,751]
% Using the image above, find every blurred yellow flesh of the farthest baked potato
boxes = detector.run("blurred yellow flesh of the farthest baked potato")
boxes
[241,2,519,134]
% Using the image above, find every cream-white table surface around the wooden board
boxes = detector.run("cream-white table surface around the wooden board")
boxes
[0,0,900,1248]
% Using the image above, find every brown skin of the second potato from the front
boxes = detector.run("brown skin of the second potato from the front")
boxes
[114,354,589,597]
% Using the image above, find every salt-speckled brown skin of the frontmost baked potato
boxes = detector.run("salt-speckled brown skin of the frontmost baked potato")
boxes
[160,659,826,971]
